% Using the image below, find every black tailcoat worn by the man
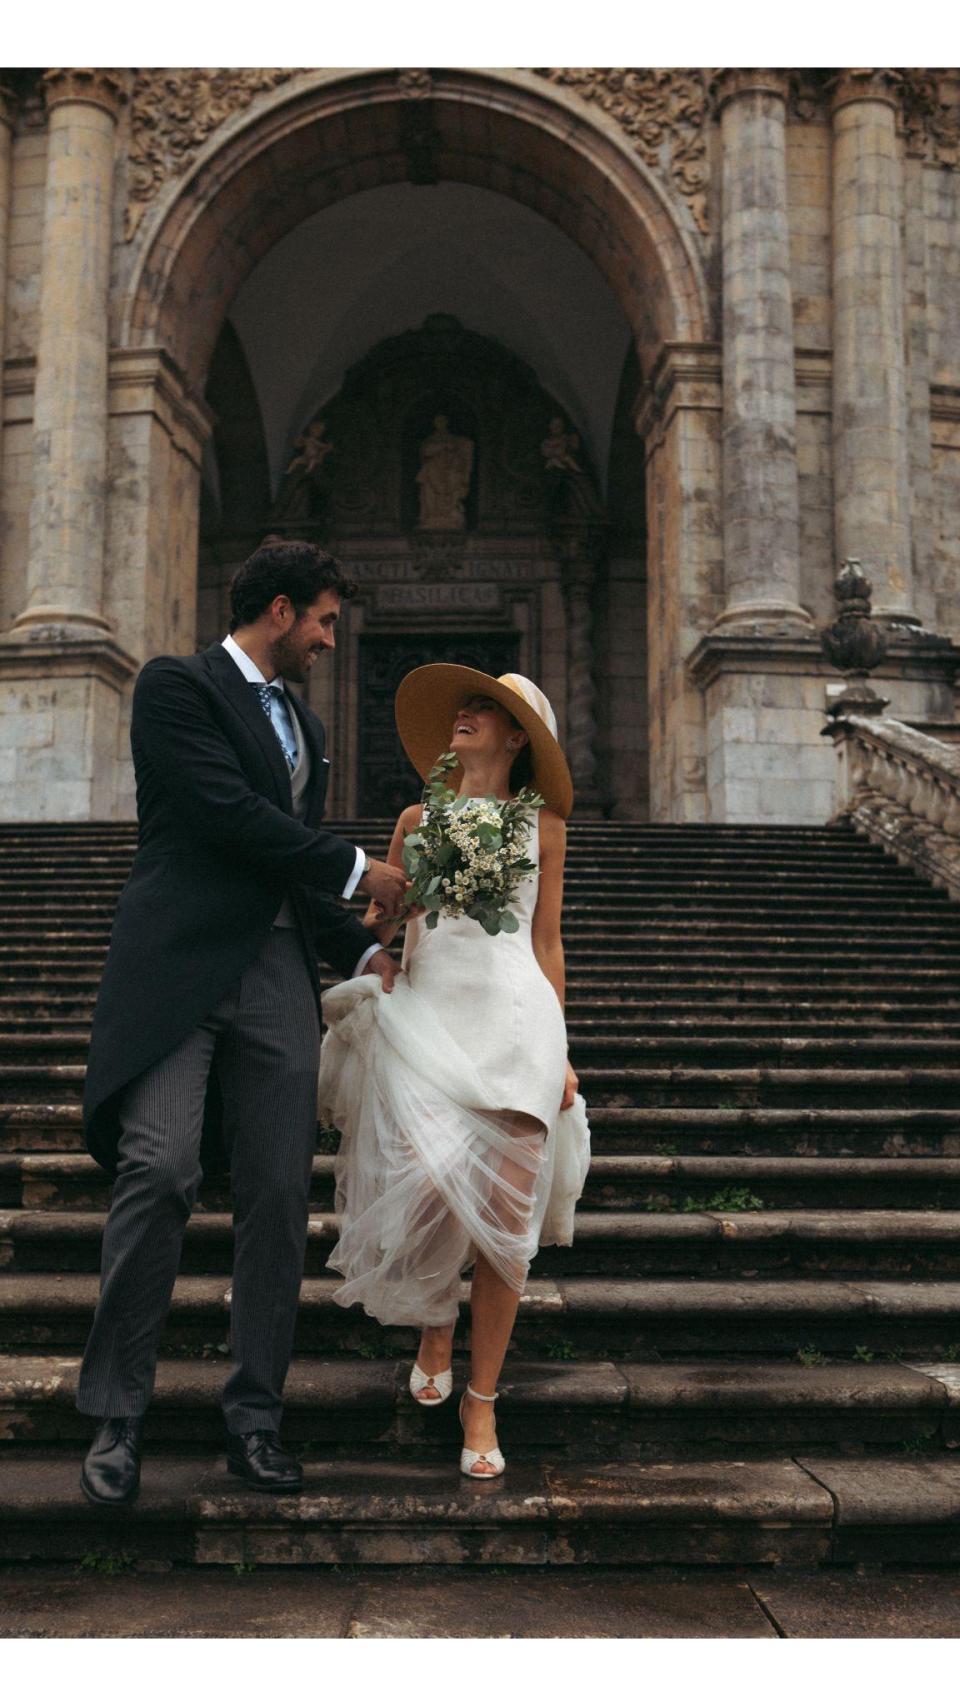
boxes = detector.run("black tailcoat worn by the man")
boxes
[84,645,375,1170]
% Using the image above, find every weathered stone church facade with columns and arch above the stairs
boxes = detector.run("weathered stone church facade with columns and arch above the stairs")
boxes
[0,68,960,824]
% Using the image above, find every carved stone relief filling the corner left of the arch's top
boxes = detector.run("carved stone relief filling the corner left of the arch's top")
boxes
[124,67,297,241]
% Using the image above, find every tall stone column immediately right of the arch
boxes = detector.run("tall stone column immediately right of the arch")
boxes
[714,70,812,633]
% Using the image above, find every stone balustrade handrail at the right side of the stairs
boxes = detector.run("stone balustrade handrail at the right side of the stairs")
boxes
[824,708,960,901]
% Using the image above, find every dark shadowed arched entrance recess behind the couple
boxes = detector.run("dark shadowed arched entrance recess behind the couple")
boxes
[198,184,630,815]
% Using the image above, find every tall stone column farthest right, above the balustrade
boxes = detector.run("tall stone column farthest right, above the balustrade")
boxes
[832,70,917,624]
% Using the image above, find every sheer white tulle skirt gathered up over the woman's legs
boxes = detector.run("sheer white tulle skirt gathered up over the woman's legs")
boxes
[319,976,590,1327]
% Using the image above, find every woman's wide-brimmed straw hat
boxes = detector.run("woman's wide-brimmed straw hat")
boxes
[396,664,573,817]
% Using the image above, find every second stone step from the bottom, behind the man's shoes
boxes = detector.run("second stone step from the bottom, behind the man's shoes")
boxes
[0,1357,960,1453]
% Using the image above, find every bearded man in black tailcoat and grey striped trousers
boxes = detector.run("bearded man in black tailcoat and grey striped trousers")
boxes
[77,537,406,1505]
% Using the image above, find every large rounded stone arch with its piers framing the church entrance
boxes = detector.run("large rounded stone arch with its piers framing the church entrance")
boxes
[104,70,721,817]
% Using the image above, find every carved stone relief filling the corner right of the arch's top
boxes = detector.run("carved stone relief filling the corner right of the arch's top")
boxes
[537,67,709,232]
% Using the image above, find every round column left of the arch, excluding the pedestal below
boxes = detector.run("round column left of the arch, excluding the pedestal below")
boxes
[10,70,124,638]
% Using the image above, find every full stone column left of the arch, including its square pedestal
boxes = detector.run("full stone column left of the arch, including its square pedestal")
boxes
[0,70,136,822]
